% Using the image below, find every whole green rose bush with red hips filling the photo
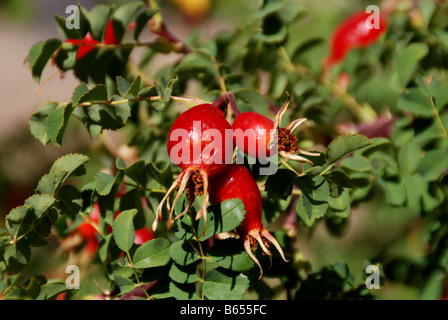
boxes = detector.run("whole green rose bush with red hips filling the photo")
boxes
[0,0,448,300]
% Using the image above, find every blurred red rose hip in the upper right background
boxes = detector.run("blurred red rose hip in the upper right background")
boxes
[328,11,387,65]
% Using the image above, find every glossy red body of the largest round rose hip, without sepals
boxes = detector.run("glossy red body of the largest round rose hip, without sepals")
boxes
[167,104,233,177]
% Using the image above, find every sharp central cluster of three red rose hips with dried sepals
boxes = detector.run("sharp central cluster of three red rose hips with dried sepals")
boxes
[153,94,318,277]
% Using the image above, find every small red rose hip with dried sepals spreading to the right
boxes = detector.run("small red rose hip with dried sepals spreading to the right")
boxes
[232,93,319,164]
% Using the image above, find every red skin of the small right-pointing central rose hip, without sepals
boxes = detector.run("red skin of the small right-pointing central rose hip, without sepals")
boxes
[232,111,274,159]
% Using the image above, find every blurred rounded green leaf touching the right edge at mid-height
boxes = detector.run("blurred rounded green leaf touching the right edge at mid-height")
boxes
[418,149,448,181]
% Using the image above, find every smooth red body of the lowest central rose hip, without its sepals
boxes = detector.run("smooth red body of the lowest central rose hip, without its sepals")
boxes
[210,164,263,237]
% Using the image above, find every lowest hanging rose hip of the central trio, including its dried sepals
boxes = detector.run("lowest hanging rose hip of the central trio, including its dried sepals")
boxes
[210,164,289,279]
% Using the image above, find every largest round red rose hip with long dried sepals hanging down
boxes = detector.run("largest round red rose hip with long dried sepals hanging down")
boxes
[153,104,234,232]
